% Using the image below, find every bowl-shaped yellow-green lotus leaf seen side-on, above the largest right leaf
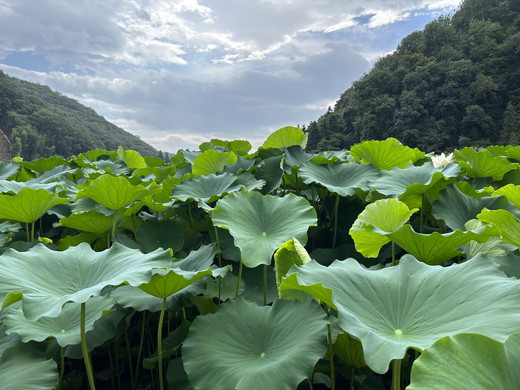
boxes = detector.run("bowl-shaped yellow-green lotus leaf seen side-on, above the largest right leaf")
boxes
[382,225,497,265]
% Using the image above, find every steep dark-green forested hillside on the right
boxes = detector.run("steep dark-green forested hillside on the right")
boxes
[307,0,520,152]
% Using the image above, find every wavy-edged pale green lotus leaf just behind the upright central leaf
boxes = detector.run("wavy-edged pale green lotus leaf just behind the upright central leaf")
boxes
[172,172,265,207]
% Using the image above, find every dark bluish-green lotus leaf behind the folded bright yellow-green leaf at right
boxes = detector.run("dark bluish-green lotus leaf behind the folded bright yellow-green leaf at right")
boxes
[432,185,515,230]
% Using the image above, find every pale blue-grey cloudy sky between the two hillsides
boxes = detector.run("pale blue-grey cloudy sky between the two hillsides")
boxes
[0,0,460,152]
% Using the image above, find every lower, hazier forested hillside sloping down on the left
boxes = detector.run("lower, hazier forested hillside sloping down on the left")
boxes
[0,71,158,160]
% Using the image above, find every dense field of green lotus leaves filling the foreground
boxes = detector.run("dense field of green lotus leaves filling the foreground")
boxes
[0,127,520,390]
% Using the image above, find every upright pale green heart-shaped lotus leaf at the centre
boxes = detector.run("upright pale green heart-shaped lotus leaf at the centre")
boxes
[211,191,317,268]
